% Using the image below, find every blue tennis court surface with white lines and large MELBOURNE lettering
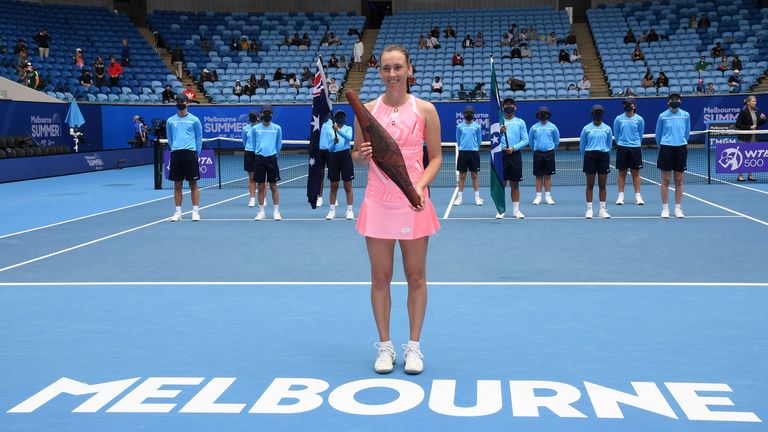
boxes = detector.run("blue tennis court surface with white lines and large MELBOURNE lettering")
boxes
[0,167,768,432]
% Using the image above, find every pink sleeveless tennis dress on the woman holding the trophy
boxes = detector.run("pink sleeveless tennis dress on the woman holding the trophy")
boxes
[357,95,440,240]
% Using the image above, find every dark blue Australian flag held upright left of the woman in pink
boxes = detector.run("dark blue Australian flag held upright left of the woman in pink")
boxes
[307,58,333,208]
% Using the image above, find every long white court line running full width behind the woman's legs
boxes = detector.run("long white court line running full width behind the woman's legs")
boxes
[0,281,768,287]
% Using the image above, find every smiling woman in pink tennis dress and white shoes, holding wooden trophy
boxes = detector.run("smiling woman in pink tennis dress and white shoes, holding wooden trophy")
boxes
[353,45,442,374]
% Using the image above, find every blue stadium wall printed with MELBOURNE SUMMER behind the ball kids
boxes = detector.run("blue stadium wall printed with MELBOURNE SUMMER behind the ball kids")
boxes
[0,94,768,151]
